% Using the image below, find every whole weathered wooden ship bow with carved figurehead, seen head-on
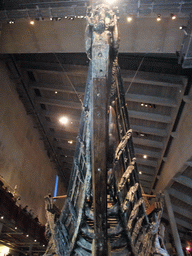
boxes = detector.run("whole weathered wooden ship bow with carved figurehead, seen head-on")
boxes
[45,4,168,256]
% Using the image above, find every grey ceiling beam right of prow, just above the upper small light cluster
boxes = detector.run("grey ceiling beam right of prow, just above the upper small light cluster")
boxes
[125,93,177,108]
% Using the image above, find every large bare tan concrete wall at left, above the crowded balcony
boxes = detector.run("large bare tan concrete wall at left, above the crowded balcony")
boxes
[0,63,66,223]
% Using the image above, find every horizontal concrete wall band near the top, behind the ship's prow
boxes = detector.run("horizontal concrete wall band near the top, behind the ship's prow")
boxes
[0,16,187,53]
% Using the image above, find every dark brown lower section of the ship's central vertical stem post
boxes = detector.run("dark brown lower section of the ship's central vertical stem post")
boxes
[92,78,108,256]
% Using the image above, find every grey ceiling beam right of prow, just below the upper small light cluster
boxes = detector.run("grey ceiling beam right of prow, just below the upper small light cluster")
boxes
[128,110,172,123]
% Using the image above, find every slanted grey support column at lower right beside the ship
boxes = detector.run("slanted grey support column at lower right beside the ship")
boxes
[164,191,184,256]
